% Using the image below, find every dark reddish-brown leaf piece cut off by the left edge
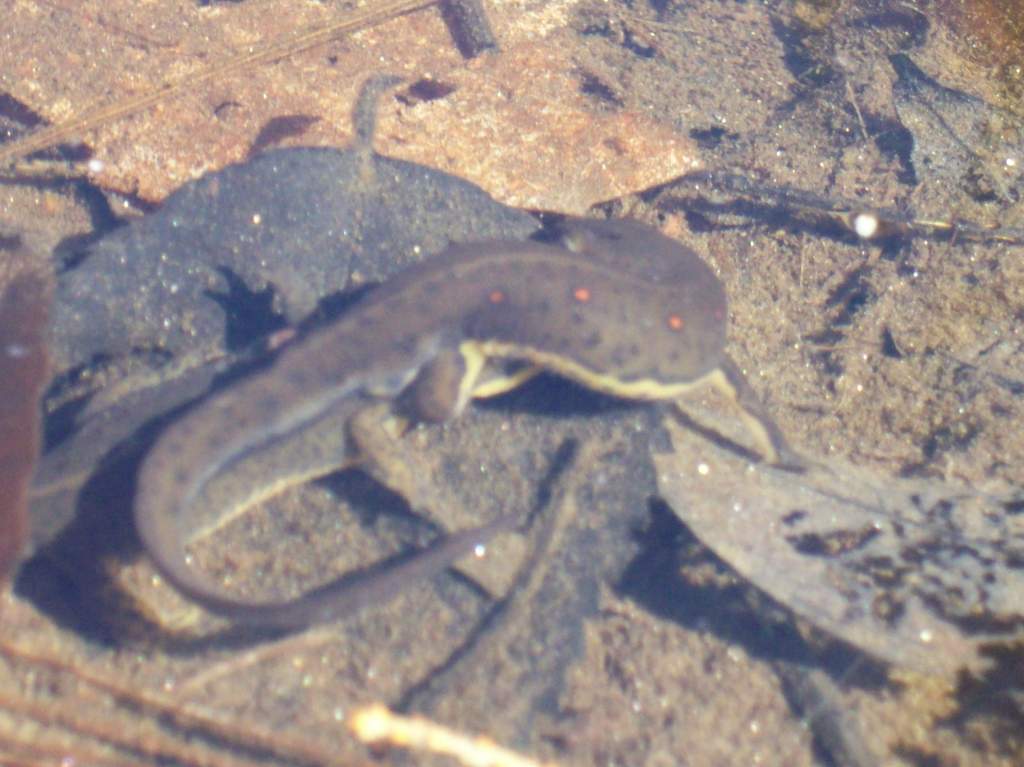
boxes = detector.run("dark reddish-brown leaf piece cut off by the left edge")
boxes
[0,272,50,581]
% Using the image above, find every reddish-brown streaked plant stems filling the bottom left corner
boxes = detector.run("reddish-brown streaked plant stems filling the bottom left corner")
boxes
[0,624,348,767]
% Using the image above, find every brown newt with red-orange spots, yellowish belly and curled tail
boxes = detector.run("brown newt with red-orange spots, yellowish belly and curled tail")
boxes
[134,219,800,628]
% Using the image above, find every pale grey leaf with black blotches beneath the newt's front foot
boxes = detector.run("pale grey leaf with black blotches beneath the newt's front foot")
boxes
[654,415,1024,676]
